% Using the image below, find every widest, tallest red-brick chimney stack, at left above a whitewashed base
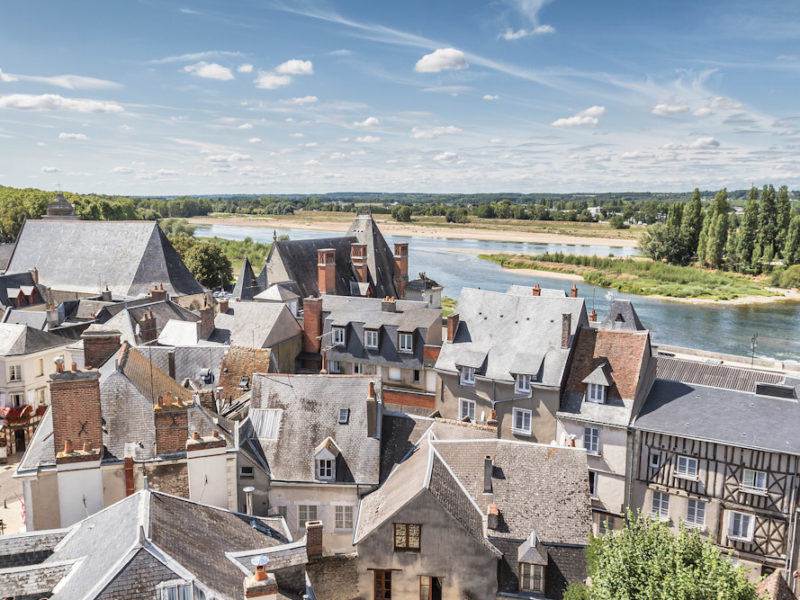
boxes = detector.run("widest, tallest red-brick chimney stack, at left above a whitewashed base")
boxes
[50,366,103,462]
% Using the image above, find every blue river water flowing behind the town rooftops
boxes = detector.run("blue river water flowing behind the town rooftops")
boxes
[195,225,800,360]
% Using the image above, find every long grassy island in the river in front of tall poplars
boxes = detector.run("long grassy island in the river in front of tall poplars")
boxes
[479,252,779,300]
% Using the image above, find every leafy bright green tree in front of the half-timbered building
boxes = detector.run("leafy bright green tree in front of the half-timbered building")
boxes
[564,513,758,600]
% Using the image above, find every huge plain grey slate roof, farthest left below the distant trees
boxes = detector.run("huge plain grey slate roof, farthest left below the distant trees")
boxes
[8,220,203,297]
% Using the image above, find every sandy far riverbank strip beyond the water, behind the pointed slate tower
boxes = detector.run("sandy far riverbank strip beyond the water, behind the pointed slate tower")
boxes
[189,212,640,248]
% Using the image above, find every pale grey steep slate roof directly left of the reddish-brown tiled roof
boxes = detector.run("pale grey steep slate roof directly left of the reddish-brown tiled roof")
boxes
[436,288,588,387]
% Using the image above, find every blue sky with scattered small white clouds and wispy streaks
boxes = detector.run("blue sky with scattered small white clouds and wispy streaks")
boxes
[0,0,800,195]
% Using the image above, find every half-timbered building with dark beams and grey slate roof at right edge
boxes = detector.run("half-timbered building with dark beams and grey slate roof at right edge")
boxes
[629,357,800,579]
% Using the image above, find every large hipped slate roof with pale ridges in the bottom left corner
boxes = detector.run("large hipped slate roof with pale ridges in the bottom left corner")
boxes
[0,490,304,600]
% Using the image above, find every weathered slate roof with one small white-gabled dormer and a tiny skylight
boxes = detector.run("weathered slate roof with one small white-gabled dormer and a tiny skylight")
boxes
[249,374,381,484]
